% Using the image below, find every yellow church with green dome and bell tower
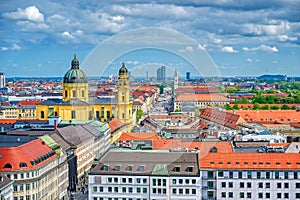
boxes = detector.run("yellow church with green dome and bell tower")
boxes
[36,55,133,127]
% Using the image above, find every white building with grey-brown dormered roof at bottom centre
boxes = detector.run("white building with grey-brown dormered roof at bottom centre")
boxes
[89,149,201,200]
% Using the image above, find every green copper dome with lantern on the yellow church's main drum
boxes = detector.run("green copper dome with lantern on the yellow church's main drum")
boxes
[64,55,87,83]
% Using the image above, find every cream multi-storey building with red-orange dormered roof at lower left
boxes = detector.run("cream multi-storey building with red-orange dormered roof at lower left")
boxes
[0,138,66,200]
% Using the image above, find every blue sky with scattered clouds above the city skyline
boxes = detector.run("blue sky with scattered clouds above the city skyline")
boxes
[0,0,300,77]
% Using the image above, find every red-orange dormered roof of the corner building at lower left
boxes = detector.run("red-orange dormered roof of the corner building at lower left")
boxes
[0,138,57,172]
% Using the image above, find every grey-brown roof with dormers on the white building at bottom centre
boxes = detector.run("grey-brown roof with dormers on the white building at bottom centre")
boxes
[90,150,199,176]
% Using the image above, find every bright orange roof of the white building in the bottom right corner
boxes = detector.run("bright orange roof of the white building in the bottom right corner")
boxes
[199,152,300,170]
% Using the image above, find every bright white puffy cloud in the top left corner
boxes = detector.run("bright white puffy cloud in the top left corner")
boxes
[3,6,44,23]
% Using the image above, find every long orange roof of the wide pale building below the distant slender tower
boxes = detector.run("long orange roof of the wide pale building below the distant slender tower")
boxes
[175,94,228,101]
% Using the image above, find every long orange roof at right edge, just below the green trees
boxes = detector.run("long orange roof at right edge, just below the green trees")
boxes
[233,110,300,123]
